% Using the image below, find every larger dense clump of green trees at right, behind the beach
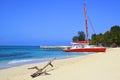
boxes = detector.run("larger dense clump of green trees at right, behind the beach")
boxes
[91,25,120,47]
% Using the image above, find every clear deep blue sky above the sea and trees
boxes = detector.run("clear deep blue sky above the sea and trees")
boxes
[0,0,120,46]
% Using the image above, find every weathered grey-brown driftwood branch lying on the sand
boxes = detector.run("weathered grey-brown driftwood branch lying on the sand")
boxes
[28,58,55,78]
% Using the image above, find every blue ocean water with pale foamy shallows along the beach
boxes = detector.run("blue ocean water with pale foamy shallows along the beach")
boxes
[0,46,92,69]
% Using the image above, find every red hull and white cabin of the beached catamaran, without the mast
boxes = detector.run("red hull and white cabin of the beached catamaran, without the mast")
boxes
[63,41,106,52]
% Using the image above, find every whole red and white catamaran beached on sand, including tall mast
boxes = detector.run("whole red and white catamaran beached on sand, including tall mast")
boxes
[63,4,106,52]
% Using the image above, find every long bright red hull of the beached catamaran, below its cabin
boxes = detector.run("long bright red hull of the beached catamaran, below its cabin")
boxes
[63,48,106,52]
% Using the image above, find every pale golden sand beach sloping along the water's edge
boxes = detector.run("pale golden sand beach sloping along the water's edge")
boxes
[0,48,120,80]
